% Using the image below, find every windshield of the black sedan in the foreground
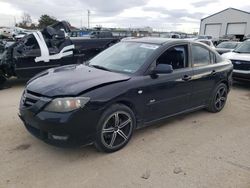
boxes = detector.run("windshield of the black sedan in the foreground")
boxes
[89,42,159,73]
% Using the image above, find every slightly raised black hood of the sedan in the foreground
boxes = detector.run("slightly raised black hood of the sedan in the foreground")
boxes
[26,65,130,97]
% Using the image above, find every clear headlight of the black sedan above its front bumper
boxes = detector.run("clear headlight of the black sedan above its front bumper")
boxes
[44,97,90,112]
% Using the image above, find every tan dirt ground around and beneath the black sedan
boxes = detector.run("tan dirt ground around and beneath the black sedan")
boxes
[0,81,250,188]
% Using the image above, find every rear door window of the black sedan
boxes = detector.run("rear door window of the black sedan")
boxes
[192,45,211,67]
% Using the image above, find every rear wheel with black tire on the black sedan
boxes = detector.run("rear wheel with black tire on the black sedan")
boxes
[207,83,228,113]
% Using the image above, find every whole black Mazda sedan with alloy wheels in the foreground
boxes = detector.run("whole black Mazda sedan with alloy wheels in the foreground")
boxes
[19,38,233,152]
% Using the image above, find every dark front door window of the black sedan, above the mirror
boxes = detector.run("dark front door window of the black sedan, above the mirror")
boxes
[156,45,188,70]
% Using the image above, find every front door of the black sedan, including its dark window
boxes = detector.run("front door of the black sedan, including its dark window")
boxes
[143,44,193,122]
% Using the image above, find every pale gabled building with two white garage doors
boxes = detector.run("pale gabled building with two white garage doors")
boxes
[200,8,250,39]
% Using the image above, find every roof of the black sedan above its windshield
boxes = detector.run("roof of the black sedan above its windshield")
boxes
[125,37,190,45]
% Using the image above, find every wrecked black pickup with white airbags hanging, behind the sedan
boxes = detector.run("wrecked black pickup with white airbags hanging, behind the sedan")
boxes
[0,21,119,84]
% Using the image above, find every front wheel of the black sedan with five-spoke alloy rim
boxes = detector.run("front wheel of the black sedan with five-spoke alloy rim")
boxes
[95,104,136,153]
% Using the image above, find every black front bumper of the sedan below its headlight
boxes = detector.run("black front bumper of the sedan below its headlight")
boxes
[19,107,101,147]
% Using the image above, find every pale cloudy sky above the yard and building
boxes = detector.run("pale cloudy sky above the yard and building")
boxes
[0,0,250,31]
